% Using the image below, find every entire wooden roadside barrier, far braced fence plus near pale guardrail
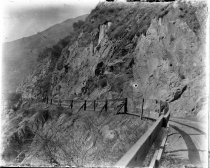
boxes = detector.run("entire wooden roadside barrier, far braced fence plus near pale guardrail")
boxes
[3,97,170,167]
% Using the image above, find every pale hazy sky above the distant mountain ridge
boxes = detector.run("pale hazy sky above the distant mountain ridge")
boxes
[2,0,102,41]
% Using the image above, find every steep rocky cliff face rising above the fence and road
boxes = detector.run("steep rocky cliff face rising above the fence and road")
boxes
[19,1,206,117]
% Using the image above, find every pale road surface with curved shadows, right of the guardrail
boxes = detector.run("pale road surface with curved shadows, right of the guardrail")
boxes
[164,118,208,167]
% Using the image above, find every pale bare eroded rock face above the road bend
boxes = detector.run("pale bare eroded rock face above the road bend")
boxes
[133,2,205,116]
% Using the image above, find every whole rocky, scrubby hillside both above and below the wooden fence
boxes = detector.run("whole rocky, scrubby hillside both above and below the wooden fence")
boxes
[3,1,207,167]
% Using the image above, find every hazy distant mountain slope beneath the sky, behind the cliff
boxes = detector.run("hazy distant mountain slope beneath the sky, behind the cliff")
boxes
[3,15,87,92]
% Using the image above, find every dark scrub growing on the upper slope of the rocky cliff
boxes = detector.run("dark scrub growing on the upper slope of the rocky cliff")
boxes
[32,3,174,100]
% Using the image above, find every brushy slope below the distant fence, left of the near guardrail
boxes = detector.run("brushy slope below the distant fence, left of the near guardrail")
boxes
[3,99,149,166]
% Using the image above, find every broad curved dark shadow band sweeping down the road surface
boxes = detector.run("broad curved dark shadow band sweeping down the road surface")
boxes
[171,125,201,164]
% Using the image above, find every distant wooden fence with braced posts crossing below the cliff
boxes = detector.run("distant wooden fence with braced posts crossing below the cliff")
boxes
[19,97,167,118]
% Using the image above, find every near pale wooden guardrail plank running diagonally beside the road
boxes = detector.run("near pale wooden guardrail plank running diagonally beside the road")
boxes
[114,112,170,167]
